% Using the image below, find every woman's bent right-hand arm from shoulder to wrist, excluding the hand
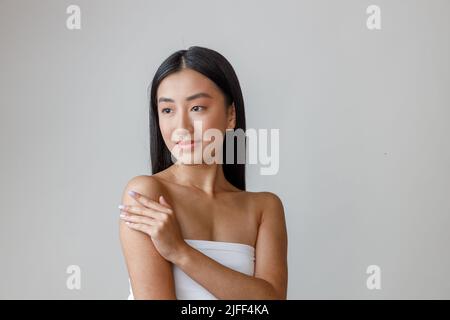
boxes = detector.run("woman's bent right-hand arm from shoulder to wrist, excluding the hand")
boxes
[172,192,288,300]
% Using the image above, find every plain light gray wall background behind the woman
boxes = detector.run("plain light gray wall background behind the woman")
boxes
[0,0,450,299]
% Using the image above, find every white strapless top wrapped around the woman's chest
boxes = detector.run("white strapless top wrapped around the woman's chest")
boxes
[128,239,255,300]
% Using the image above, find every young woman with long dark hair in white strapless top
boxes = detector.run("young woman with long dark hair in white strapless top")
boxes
[119,47,288,299]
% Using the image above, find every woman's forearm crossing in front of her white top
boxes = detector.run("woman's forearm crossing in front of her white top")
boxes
[172,245,280,300]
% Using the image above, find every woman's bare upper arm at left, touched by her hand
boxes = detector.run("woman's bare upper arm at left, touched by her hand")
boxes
[119,176,176,300]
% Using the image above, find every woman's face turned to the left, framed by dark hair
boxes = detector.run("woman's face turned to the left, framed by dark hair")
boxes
[156,69,236,164]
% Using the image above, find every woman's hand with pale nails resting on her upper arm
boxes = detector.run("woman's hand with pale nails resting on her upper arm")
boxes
[119,191,186,262]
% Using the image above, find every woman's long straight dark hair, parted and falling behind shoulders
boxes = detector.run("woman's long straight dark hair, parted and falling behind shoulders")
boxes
[149,46,246,190]
